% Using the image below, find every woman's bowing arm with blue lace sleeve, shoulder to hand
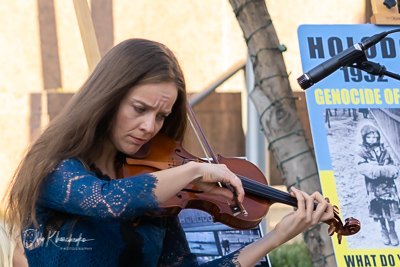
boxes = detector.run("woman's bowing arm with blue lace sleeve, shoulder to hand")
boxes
[38,159,244,219]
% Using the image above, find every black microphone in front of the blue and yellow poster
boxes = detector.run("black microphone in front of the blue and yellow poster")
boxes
[297,32,390,90]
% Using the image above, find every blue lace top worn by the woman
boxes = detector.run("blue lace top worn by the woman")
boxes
[22,159,240,267]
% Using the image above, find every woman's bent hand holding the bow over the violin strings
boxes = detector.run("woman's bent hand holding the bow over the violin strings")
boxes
[193,163,244,202]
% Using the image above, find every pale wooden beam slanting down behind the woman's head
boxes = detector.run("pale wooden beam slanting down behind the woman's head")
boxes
[74,0,101,73]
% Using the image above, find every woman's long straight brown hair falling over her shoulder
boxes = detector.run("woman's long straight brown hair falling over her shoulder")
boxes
[6,39,186,233]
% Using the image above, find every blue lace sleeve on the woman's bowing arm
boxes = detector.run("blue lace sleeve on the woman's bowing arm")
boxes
[38,159,158,219]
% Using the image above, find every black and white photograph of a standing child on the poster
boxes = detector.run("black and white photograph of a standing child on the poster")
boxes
[324,108,400,249]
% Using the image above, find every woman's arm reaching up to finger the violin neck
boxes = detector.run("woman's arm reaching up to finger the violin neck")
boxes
[159,188,333,267]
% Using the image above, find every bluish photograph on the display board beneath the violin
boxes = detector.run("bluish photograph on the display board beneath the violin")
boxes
[179,209,271,267]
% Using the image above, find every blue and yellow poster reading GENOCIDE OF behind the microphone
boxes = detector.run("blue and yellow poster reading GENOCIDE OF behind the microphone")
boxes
[298,24,400,267]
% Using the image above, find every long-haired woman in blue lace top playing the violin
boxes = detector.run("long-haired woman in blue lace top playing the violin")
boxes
[7,39,333,266]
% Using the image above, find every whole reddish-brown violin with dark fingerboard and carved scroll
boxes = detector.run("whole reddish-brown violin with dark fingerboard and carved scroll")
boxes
[118,133,360,244]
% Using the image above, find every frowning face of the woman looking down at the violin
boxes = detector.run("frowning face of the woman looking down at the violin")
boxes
[111,82,178,155]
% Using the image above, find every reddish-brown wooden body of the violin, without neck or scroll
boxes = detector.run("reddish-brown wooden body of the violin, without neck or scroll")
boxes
[121,134,270,229]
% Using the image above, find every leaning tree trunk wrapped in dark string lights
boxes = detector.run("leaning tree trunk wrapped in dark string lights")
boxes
[229,0,336,266]
